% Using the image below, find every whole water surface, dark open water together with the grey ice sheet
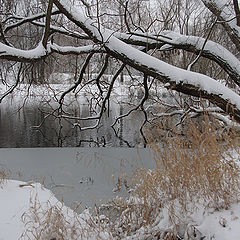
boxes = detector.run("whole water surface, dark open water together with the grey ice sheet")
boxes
[0,82,155,211]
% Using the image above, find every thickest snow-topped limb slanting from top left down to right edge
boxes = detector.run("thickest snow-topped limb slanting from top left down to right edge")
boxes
[54,0,240,121]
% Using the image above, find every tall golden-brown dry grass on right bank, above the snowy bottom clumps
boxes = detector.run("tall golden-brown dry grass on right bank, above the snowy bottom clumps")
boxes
[135,117,240,227]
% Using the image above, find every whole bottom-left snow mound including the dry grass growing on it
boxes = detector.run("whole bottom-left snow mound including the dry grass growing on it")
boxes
[0,180,110,240]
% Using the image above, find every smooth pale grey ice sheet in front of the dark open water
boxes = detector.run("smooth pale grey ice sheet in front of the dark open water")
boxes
[0,148,155,212]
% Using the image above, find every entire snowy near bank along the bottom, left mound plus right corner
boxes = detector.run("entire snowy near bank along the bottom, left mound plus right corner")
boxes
[0,177,240,240]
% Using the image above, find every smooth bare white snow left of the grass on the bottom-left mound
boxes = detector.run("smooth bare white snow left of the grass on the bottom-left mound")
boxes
[0,180,58,240]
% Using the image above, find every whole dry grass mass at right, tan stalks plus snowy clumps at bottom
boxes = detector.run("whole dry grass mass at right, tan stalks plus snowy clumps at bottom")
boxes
[104,117,240,239]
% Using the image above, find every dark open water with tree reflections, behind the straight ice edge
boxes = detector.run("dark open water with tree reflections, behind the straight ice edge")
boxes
[0,98,142,148]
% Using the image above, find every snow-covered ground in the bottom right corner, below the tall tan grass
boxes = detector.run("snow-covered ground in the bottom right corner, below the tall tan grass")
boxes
[125,201,240,240]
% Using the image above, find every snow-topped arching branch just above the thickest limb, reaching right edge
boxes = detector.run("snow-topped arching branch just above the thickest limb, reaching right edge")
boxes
[114,30,240,86]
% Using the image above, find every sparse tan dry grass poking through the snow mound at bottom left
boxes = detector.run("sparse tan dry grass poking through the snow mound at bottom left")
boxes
[20,195,112,240]
